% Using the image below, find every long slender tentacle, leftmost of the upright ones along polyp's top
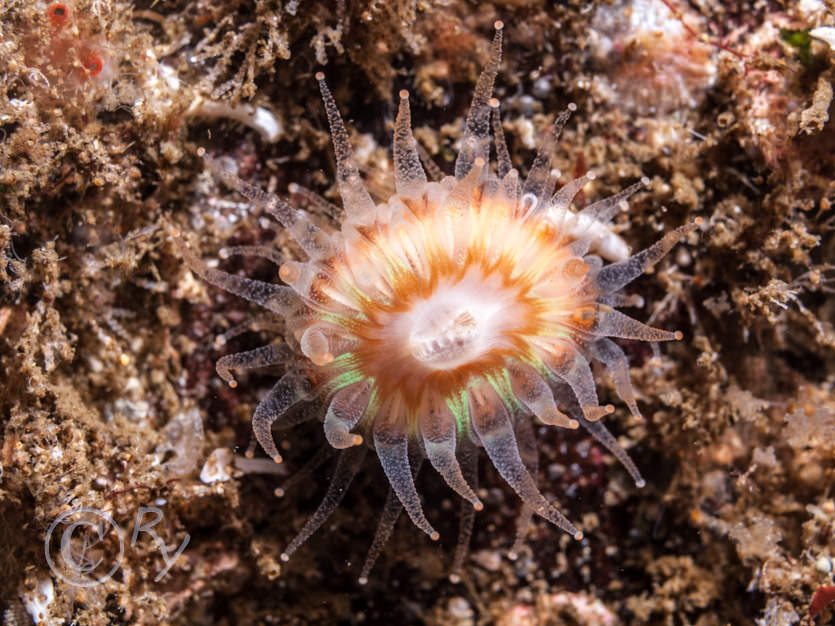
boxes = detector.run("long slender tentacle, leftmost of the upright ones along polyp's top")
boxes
[316,72,375,224]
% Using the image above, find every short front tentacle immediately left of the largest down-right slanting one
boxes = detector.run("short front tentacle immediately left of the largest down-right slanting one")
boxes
[419,395,484,511]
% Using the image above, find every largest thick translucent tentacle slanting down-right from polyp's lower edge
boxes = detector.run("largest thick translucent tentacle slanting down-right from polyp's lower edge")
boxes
[468,386,583,540]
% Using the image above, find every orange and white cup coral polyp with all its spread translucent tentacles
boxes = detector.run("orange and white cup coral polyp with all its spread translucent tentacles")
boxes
[181,22,695,579]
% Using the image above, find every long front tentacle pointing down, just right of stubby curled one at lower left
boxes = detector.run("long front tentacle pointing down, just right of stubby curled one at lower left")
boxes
[374,407,439,541]
